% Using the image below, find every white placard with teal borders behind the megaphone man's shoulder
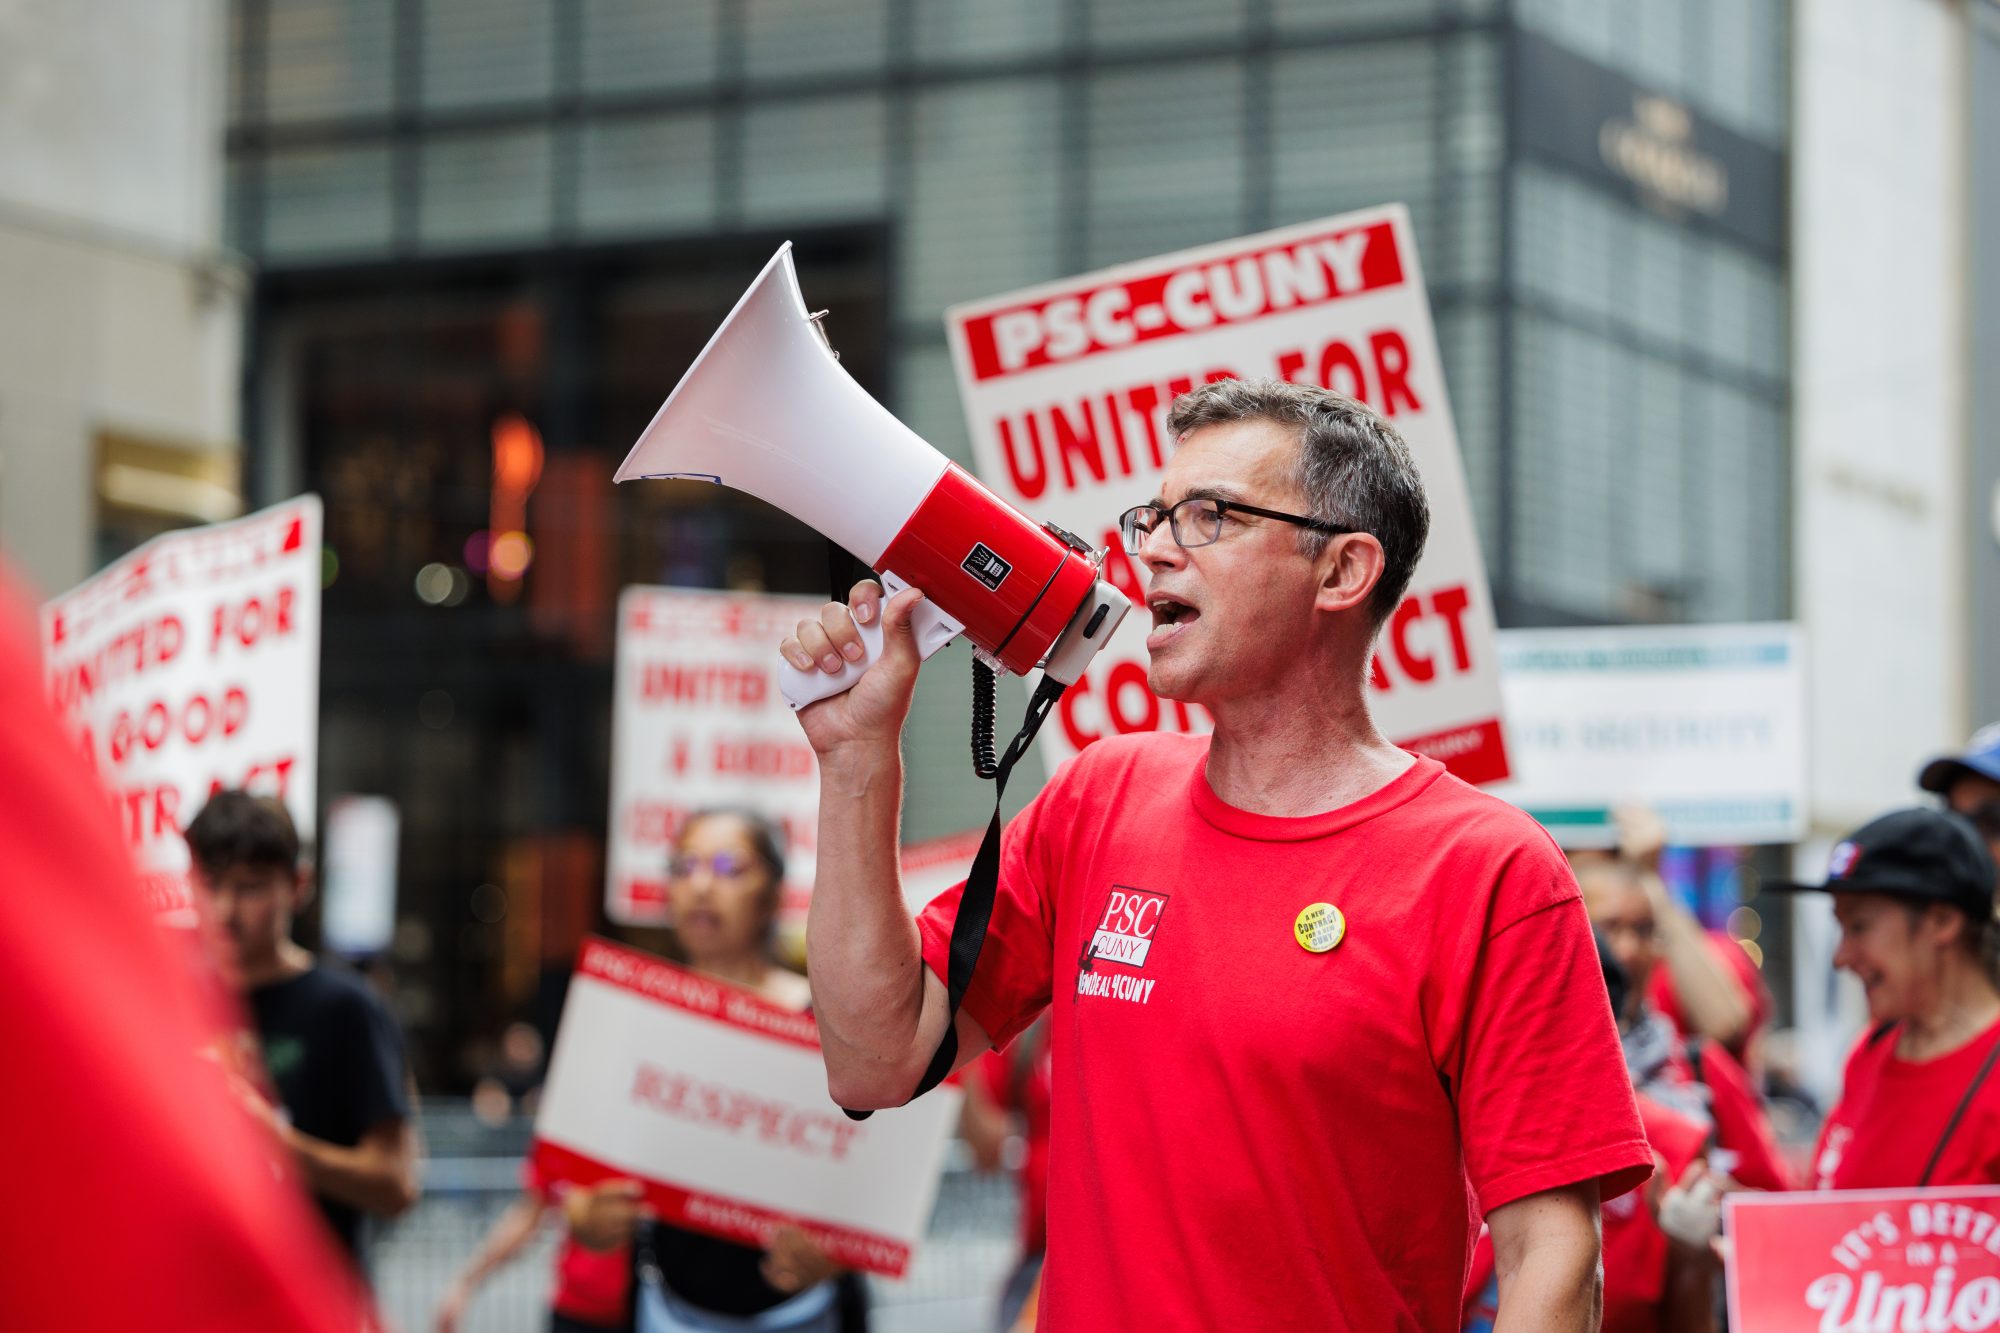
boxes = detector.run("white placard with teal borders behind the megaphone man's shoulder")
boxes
[1492,624,1806,847]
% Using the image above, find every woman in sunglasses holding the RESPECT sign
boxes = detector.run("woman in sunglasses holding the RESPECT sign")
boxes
[438,809,868,1333]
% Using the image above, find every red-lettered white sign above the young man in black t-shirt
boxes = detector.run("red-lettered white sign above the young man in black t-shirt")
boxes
[42,494,322,925]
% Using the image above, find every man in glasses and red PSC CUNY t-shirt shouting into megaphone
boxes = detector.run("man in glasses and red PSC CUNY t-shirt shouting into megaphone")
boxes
[780,380,1652,1333]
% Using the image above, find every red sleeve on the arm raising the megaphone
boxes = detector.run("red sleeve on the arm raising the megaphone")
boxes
[916,761,1082,1051]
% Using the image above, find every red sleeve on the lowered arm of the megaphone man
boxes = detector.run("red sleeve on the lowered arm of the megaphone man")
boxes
[1456,847,1652,1213]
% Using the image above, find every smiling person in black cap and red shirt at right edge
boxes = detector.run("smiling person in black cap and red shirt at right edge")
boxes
[1766,809,2000,1189]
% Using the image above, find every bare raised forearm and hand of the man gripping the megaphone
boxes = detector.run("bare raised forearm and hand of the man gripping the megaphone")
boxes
[780,580,988,1111]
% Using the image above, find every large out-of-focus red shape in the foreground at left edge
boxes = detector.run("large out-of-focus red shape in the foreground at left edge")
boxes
[0,570,376,1333]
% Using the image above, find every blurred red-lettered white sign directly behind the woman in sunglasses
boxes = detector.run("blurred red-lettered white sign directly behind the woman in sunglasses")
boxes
[604,586,820,935]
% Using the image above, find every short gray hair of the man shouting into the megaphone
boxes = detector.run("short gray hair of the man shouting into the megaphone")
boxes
[1166,380,1430,624]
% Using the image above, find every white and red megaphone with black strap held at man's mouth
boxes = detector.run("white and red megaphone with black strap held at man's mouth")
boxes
[616,242,1132,709]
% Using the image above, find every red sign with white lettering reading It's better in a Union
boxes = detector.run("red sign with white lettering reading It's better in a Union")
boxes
[1722,1185,2000,1333]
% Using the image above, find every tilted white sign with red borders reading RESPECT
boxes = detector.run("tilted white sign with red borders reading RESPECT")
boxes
[534,939,958,1277]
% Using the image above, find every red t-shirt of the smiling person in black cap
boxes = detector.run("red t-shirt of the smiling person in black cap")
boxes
[1812,1023,2000,1189]
